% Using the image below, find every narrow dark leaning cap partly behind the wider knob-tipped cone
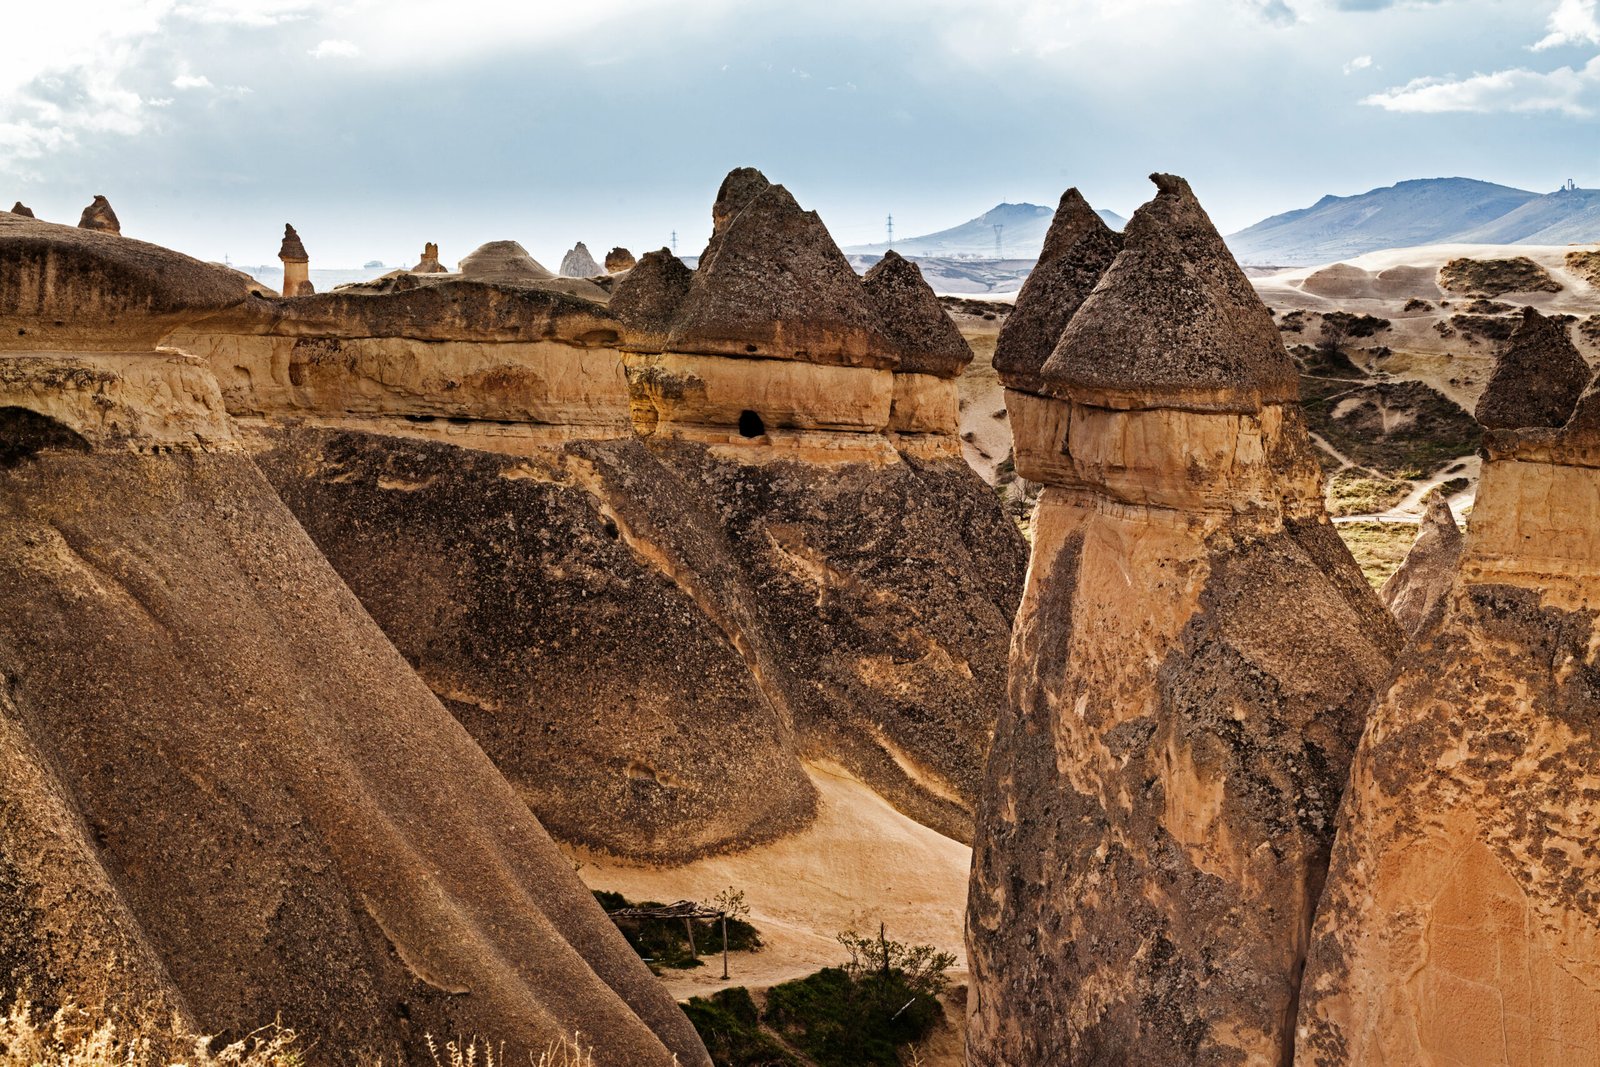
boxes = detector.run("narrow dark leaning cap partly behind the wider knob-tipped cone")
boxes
[994,189,1122,392]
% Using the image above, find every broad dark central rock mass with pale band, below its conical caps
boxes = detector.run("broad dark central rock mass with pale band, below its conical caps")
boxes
[171,168,1026,861]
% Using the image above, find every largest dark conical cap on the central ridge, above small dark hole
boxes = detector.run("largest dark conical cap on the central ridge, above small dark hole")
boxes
[662,168,898,368]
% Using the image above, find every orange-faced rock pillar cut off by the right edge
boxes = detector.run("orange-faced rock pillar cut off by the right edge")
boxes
[1294,343,1600,1067]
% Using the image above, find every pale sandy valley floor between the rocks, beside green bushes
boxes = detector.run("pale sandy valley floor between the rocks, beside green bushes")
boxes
[574,761,971,1000]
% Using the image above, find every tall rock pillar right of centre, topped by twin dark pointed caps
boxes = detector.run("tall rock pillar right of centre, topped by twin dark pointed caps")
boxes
[968,174,1400,1064]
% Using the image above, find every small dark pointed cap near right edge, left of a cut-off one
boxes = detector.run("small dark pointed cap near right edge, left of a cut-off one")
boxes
[1472,307,1589,430]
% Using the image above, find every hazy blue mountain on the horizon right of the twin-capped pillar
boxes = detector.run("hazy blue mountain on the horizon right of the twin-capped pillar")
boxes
[1227,178,1600,267]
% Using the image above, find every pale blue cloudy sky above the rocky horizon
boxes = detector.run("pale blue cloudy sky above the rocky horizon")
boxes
[0,0,1600,267]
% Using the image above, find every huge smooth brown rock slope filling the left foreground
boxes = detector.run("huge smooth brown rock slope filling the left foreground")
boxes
[0,207,709,1065]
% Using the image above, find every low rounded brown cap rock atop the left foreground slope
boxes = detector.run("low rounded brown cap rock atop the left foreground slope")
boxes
[0,213,253,349]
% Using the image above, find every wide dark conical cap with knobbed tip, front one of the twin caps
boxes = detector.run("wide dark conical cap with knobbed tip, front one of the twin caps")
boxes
[1040,174,1299,413]
